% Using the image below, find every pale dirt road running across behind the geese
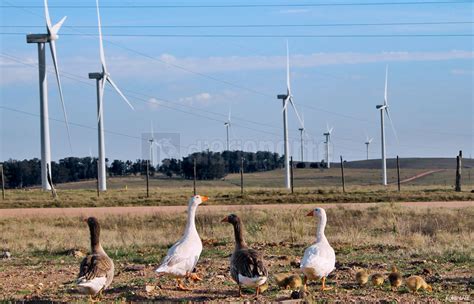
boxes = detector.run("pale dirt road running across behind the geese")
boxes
[0,201,474,218]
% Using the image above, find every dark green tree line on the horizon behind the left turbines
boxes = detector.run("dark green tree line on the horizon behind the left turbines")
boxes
[3,151,284,188]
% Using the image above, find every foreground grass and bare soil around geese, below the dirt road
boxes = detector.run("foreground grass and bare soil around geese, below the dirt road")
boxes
[0,204,474,302]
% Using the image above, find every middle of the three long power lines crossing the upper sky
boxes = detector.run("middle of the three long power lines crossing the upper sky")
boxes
[0,21,474,29]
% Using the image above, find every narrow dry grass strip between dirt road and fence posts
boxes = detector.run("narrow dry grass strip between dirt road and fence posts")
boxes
[0,185,474,208]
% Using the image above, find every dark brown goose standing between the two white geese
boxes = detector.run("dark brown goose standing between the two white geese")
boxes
[222,214,268,297]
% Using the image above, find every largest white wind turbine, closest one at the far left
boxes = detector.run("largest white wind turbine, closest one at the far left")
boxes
[26,0,72,190]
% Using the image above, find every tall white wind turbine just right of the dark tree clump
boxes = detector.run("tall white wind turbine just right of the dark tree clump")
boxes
[277,41,303,189]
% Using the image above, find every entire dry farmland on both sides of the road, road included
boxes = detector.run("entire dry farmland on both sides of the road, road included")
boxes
[0,168,474,302]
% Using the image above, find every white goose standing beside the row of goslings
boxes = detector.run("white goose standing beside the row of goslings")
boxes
[301,208,336,291]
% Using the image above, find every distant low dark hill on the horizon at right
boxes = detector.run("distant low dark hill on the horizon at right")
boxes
[344,158,474,169]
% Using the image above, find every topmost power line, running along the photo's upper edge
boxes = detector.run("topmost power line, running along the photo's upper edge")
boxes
[0,0,472,9]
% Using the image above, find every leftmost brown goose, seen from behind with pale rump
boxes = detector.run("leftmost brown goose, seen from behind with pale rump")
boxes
[77,217,114,300]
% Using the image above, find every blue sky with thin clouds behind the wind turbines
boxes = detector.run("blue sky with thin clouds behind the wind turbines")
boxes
[0,0,474,164]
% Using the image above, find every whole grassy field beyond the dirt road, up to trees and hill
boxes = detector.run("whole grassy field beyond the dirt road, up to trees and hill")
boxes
[0,168,474,208]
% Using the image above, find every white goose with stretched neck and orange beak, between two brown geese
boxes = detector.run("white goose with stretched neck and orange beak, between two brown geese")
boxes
[156,195,208,290]
